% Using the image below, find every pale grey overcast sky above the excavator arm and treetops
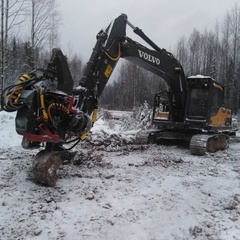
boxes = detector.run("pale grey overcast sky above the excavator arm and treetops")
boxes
[59,0,240,61]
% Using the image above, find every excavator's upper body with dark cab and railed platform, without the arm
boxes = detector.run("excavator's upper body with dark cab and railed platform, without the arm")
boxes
[153,75,232,131]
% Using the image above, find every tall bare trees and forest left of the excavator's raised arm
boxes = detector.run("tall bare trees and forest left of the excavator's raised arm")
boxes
[0,0,83,89]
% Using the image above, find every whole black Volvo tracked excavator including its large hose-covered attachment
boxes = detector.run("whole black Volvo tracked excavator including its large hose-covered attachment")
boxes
[1,14,232,186]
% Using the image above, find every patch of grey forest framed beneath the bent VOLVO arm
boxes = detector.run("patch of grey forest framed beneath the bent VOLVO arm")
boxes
[100,61,166,110]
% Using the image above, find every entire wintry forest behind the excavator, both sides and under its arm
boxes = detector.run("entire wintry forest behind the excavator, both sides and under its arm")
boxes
[0,0,240,113]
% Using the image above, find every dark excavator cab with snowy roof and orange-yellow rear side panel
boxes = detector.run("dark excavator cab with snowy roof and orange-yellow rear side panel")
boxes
[185,76,232,130]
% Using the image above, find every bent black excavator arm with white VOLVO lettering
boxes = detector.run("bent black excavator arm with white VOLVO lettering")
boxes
[74,14,186,121]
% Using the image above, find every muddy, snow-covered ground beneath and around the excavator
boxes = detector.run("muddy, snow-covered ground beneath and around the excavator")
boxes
[0,112,240,240]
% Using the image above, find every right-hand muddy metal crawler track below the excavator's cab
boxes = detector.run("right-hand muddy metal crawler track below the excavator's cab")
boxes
[190,134,229,156]
